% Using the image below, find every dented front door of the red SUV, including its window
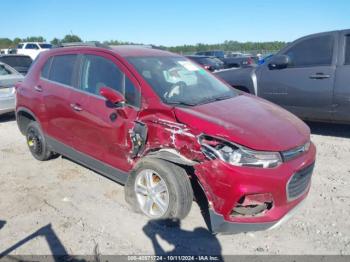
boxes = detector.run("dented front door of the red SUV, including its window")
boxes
[70,52,140,171]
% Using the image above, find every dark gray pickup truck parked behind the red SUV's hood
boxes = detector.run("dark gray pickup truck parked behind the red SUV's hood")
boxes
[217,29,350,123]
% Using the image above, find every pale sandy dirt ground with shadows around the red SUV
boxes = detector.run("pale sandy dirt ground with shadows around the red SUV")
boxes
[0,114,350,255]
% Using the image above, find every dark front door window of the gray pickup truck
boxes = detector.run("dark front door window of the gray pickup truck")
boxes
[285,35,334,67]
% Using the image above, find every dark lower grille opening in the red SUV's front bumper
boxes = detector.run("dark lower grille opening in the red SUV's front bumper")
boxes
[287,164,315,201]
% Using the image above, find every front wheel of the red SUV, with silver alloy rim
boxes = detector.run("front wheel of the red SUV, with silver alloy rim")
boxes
[125,158,193,221]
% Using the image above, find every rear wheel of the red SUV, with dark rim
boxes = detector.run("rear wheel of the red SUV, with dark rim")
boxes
[26,121,59,161]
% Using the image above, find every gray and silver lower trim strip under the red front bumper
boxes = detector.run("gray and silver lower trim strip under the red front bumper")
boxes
[209,196,304,234]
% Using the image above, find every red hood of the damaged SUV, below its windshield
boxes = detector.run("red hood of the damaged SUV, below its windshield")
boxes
[174,95,310,151]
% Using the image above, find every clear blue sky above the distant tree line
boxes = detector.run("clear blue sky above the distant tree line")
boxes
[0,0,350,46]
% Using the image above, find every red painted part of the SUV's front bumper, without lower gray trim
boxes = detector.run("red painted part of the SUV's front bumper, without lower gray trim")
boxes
[196,144,316,223]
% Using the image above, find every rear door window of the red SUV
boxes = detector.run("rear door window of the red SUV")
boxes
[48,55,77,86]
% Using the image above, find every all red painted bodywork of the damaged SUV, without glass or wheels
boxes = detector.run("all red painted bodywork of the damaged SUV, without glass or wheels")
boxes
[17,47,316,231]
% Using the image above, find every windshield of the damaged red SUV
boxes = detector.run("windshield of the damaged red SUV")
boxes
[128,56,237,106]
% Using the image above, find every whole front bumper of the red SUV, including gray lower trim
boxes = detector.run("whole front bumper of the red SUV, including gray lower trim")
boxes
[196,144,316,233]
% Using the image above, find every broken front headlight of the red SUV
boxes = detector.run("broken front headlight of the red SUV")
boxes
[199,136,282,168]
